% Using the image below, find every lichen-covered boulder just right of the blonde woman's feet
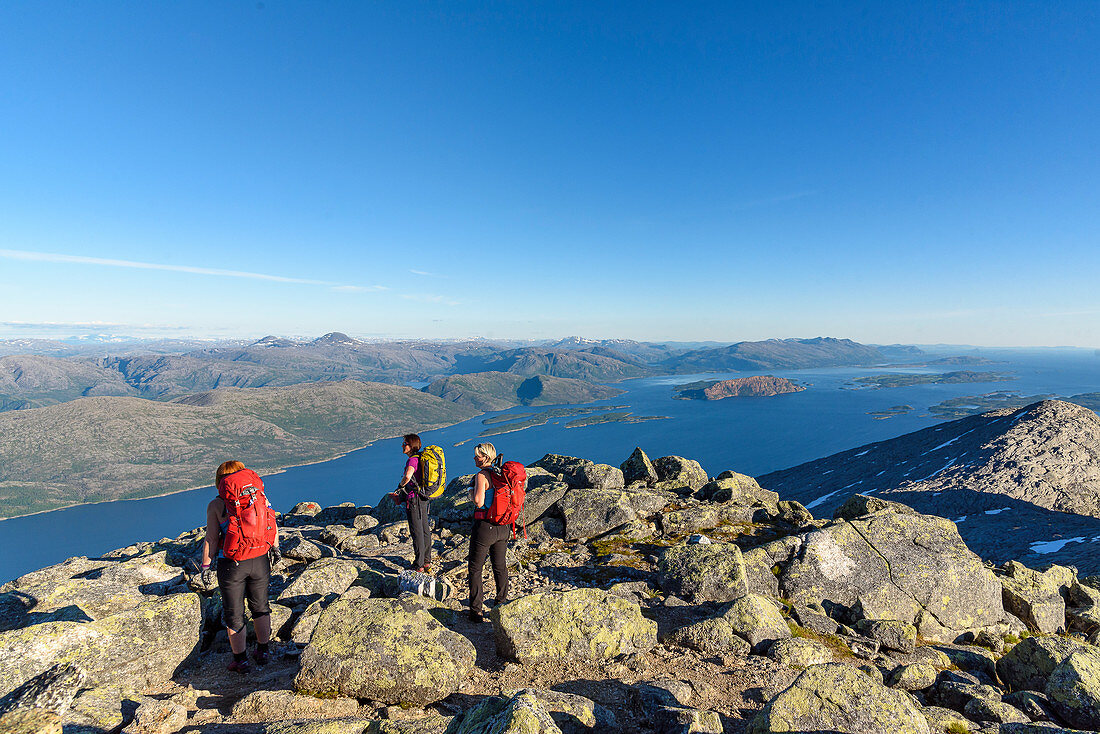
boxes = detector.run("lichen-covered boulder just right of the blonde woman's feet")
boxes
[495,589,657,665]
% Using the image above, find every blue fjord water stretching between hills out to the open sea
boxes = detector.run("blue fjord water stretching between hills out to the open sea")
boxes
[0,349,1100,582]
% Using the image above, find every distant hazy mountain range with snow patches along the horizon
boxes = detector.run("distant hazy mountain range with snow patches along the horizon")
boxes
[0,332,884,410]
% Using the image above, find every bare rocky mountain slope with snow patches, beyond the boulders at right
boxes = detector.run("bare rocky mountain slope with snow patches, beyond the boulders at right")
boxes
[760,401,1100,570]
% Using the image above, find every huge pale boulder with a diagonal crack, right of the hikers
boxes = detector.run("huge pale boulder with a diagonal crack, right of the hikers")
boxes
[780,510,1004,642]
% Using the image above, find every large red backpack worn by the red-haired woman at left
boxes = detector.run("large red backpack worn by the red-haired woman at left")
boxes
[218,469,277,561]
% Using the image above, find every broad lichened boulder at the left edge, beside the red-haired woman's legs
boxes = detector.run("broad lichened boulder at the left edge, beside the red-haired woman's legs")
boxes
[0,593,202,695]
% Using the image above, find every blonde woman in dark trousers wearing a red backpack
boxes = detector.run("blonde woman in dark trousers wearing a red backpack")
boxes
[466,443,527,622]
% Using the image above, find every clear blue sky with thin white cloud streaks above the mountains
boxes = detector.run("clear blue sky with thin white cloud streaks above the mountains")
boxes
[0,0,1100,347]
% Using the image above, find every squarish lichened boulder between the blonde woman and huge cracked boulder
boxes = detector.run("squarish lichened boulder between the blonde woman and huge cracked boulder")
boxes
[658,543,748,602]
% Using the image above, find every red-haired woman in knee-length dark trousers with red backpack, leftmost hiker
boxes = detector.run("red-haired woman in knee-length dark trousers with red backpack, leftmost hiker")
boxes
[202,461,283,673]
